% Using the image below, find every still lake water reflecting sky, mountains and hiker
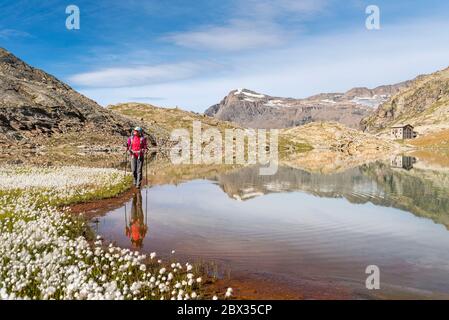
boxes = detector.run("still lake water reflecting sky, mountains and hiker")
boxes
[95,157,449,298]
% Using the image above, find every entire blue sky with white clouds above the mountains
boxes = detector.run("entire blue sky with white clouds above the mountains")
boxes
[0,0,449,112]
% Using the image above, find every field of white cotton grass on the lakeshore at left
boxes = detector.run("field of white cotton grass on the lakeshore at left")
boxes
[0,167,212,300]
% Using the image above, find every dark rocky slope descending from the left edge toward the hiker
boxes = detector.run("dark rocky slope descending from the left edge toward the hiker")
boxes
[0,48,154,149]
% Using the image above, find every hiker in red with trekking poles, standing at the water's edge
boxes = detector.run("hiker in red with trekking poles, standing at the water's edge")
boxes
[126,127,148,189]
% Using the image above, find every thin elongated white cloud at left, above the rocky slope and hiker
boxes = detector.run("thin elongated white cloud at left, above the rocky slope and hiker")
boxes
[69,62,217,88]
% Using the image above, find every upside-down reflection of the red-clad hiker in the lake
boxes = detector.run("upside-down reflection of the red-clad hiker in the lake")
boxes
[125,192,148,249]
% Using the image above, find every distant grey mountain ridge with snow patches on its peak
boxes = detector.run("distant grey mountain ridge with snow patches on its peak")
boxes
[205,82,409,128]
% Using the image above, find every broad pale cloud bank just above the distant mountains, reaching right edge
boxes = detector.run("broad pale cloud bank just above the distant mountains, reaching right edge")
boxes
[77,21,449,112]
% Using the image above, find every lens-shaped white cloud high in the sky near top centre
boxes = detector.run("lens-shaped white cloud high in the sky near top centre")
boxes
[163,20,286,51]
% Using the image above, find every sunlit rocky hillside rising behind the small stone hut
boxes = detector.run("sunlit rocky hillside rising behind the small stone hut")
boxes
[361,68,449,136]
